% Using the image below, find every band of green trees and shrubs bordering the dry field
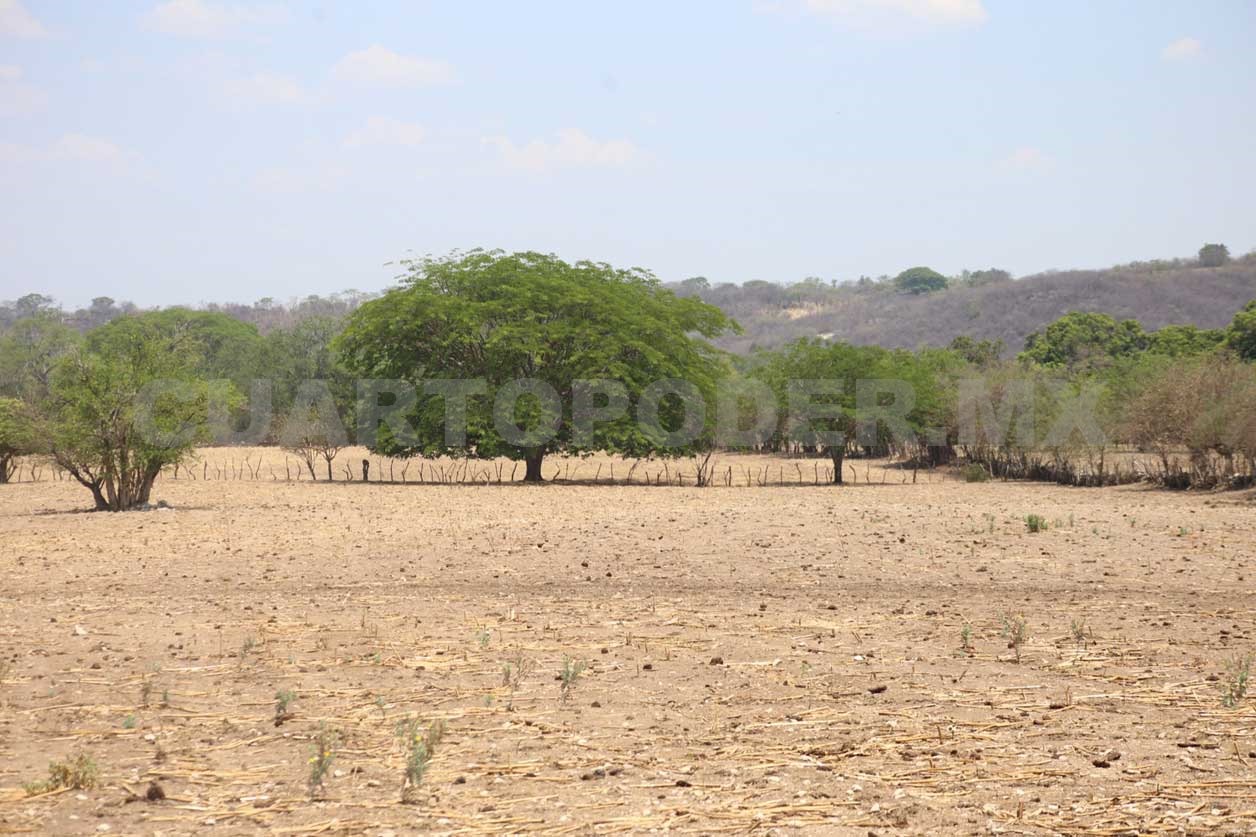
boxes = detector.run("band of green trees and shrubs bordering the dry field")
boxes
[0,250,1256,510]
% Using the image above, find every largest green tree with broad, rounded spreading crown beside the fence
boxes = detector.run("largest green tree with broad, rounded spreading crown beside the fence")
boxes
[337,250,736,481]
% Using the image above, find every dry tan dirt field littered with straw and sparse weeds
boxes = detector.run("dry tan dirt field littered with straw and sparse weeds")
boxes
[0,451,1256,834]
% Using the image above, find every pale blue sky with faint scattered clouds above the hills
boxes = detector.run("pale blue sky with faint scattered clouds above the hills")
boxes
[0,0,1256,307]
